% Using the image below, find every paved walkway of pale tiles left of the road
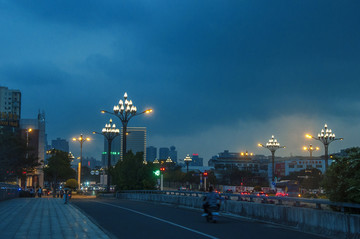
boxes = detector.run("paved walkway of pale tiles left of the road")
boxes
[0,197,109,239]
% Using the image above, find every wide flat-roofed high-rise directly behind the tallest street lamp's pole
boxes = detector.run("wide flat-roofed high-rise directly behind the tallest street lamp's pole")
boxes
[120,127,146,161]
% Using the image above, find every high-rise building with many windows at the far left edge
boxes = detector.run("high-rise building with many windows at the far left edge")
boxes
[0,87,21,128]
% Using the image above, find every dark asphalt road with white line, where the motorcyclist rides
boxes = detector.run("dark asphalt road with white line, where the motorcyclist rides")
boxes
[71,199,324,239]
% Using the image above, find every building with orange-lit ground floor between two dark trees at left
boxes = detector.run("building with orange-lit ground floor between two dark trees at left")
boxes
[19,112,46,188]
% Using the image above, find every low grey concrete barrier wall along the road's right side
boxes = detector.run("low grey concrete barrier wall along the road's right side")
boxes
[117,193,360,239]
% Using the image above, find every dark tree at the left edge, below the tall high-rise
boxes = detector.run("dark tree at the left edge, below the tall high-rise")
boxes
[0,131,40,181]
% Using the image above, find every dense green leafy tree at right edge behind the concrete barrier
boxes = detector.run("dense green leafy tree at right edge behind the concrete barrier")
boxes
[322,147,360,203]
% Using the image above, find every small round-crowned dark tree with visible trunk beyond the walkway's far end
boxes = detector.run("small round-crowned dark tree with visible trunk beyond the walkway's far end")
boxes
[44,150,76,195]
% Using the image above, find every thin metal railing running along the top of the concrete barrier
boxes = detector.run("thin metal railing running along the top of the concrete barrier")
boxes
[117,190,360,212]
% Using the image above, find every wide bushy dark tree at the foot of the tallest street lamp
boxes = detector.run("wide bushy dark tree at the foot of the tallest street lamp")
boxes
[110,151,156,190]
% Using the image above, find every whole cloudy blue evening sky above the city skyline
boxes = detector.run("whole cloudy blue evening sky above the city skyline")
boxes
[0,0,360,161]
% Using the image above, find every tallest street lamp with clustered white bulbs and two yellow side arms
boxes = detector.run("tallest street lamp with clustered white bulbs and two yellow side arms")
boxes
[101,92,152,158]
